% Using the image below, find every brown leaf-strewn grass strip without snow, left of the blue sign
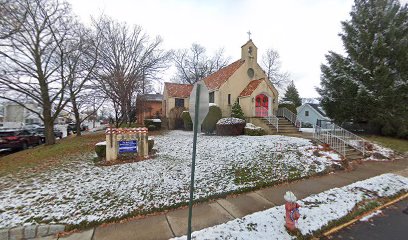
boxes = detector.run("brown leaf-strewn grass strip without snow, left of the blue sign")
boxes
[0,133,105,176]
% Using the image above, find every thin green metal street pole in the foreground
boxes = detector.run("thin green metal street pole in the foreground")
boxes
[187,84,200,240]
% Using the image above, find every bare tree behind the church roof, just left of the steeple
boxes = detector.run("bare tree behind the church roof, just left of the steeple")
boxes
[172,43,229,84]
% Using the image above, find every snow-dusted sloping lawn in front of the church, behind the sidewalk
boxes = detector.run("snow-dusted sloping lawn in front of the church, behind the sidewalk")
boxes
[0,131,342,228]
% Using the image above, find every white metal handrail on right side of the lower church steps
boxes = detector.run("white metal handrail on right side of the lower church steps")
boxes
[315,121,367,155]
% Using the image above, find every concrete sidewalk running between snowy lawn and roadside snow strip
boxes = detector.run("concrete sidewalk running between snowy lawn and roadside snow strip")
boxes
[42,159,408,240]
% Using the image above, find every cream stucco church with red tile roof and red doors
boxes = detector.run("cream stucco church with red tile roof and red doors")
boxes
[162,40,278,124]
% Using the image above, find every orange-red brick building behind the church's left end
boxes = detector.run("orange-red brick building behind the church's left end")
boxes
[136,93,163,124]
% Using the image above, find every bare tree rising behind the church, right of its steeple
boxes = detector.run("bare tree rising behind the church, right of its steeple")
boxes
[262,48,290,89]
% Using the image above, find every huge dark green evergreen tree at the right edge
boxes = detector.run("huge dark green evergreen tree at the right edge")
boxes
[317,0,408,137]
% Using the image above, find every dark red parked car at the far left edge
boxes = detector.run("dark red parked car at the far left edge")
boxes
[0,129,42,150]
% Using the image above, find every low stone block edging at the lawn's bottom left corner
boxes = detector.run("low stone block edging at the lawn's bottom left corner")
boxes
[0,224,65,240]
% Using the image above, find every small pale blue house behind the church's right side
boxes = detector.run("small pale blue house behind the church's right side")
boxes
[296,103,330,128]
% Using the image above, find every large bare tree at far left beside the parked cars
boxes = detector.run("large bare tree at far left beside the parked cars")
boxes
[0,0,72,144]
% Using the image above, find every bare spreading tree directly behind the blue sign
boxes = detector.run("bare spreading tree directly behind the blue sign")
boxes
[93,16,169,126]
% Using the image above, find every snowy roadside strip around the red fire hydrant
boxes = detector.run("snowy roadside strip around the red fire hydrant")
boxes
[174,174,408,240]
